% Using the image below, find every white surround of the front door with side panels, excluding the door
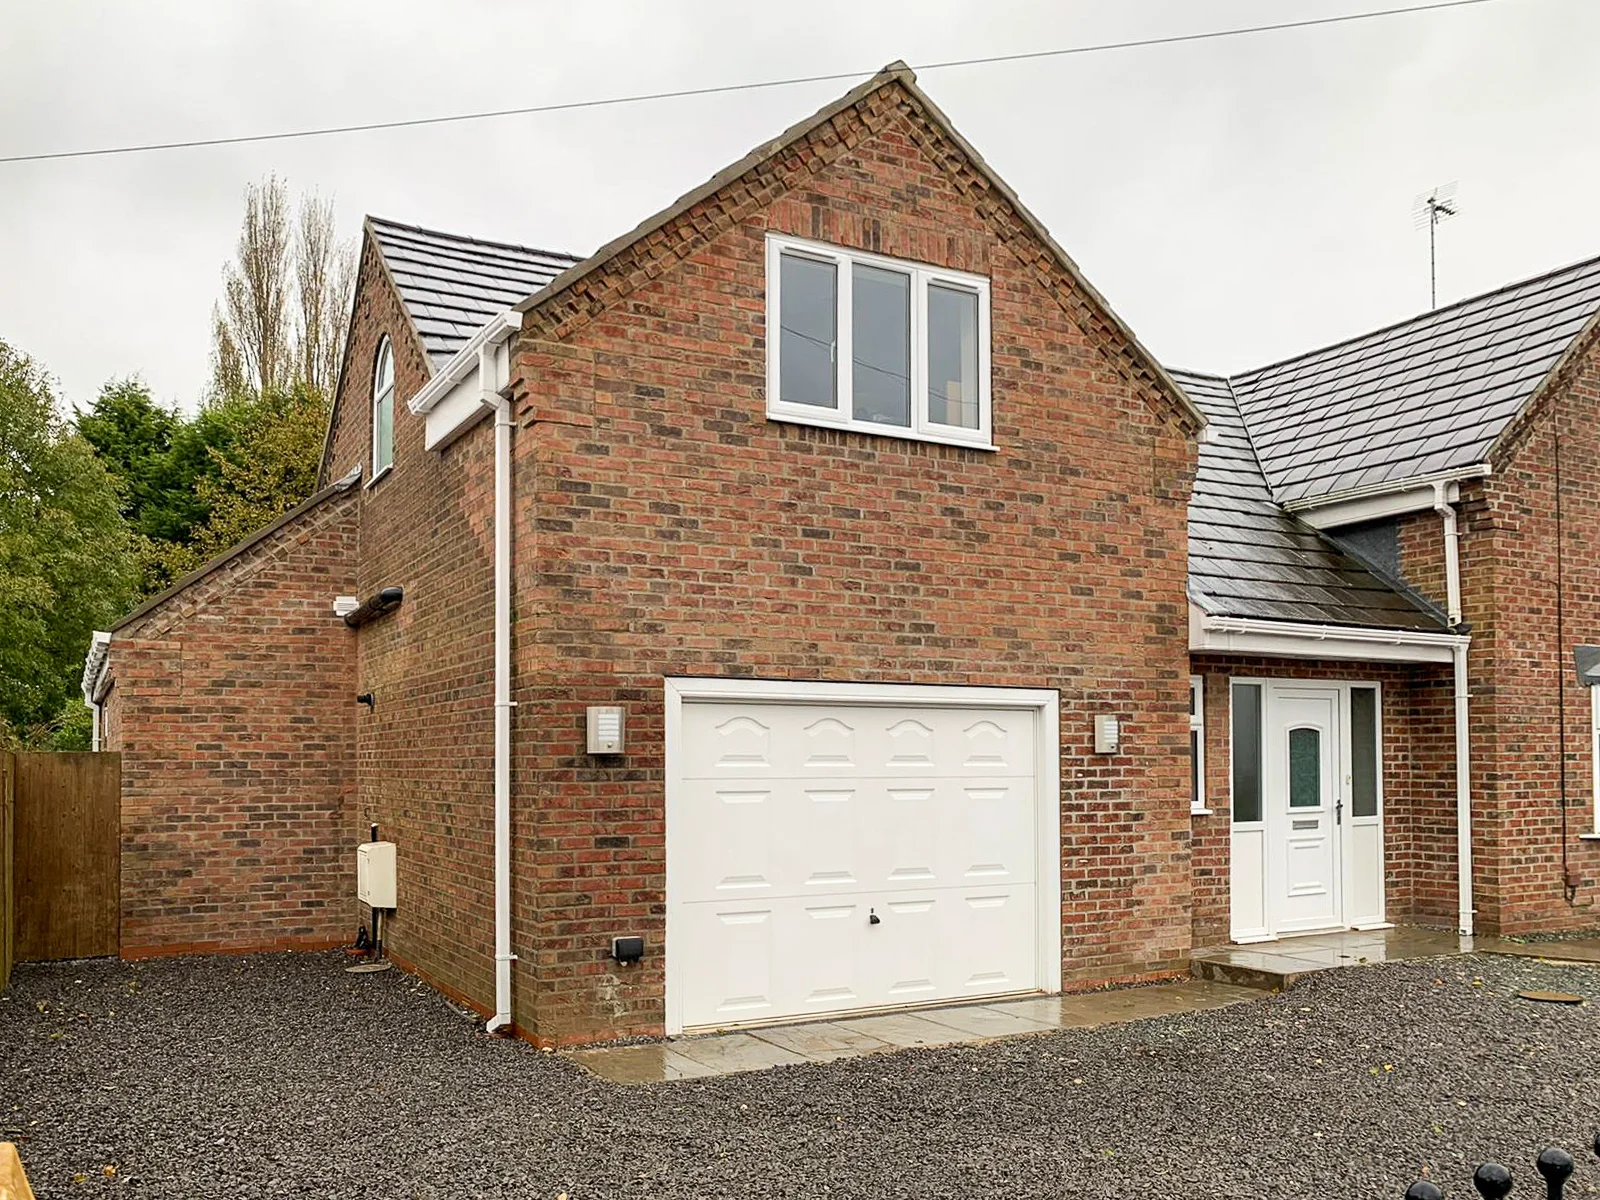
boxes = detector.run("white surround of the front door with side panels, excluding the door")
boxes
[1227,675,1387,942]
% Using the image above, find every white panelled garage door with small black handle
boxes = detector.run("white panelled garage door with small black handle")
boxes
[667,688,1056,1032]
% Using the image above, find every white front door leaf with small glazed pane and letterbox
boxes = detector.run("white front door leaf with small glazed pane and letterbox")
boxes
[1266,685,1342,933]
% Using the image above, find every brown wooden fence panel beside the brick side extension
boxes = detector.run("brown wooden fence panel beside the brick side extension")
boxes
[13,754,122,962]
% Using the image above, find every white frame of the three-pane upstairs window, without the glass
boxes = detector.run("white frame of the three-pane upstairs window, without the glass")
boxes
[766,234,994,450]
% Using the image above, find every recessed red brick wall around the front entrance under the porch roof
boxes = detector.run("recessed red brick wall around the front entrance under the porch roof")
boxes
[1192,654,1456,947]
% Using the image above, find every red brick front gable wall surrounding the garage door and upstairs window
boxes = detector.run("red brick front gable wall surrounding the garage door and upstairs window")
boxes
[517,82,1194,1042]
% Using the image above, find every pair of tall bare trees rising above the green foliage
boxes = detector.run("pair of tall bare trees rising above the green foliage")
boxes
[211,176,355,397]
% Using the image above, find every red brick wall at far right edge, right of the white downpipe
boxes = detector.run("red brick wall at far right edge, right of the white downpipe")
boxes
[1472,331,1600,934]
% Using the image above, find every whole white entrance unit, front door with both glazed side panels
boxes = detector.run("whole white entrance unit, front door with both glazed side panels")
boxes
[1230,678,1384,941]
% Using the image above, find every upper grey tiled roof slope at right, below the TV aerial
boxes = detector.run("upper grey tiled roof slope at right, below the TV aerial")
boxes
[1229,258,1600,504]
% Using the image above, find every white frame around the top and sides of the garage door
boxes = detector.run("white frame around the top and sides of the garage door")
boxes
[664,675,1061,1037]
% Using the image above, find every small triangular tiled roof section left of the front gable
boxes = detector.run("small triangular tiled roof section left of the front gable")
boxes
[366,216,579,370]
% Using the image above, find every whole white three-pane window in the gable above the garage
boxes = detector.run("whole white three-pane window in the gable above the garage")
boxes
[766,235,994,446]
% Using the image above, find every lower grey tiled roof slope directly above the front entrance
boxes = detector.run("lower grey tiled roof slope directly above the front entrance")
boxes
[1171,371,1445,630]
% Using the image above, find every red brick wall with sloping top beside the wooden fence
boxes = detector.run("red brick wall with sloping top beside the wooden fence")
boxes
[102,493,357,955]
